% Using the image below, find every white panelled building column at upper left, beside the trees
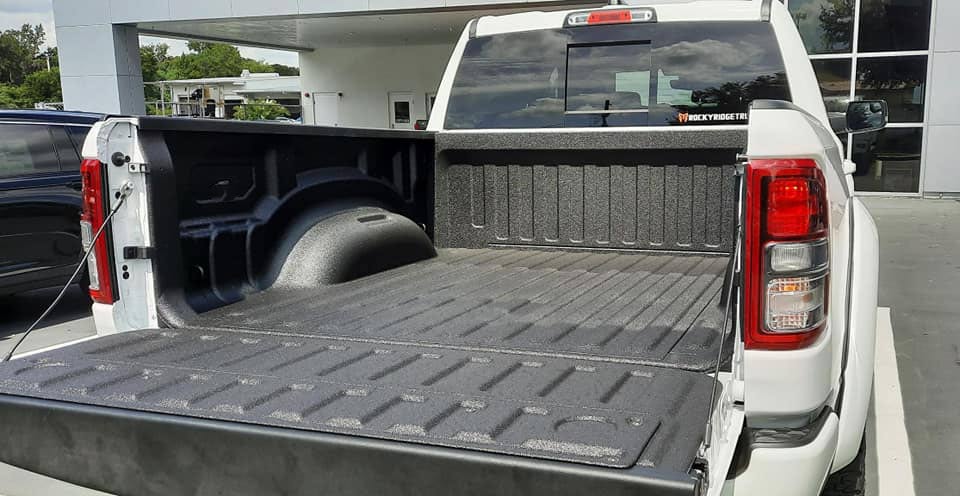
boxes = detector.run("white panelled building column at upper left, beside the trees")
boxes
[53,0,145,115]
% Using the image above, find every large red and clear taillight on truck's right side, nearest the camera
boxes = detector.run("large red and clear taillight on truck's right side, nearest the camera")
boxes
[744,159,829,350]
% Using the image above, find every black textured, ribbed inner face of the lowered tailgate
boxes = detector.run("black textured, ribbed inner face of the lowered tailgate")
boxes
[0,328,713,472]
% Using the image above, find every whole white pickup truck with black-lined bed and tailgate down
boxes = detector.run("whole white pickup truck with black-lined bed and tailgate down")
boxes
[0,0,886,496]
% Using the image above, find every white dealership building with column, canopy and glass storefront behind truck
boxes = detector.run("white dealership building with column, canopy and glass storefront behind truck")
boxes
[54,0,960,196]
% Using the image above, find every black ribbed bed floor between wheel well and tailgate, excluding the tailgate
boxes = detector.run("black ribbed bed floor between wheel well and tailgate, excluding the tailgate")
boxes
[196,248,728,371]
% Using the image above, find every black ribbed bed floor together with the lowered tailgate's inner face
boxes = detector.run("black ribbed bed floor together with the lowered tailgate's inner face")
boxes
[0,249,727,480]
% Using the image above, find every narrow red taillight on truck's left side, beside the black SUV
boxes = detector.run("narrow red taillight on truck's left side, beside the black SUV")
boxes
[80,158,114,303]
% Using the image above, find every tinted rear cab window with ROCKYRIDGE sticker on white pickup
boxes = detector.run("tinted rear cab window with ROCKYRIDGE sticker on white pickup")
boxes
[444,22,790,129]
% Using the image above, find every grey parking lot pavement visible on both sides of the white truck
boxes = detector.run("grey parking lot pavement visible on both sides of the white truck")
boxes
[0,198,960,496]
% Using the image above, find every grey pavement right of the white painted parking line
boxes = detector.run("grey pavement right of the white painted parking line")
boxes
[864,198,960,495]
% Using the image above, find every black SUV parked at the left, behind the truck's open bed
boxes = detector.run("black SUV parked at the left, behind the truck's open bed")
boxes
[0,110,104,296]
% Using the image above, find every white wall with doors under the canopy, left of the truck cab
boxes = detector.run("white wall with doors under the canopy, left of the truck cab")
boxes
[300,44,453,128]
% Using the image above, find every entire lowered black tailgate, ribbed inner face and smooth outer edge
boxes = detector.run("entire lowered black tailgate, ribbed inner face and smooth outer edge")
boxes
[0,329,712,494]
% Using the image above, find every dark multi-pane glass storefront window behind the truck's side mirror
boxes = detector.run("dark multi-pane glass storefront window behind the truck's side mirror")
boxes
[786,0,932,193]
